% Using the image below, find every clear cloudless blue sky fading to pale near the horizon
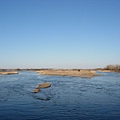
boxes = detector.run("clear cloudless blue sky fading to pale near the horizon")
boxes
[0,0,120,68]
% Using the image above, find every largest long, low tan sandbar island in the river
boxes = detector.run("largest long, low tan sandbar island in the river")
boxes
[37,69,99,78]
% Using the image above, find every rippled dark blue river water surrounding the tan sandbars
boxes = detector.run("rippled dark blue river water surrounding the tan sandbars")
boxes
[0,71,120,120]
